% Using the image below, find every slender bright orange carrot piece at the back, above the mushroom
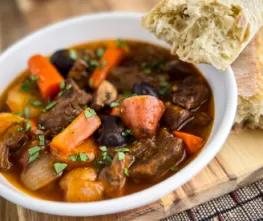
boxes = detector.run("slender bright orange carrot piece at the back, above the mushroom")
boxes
[89,47,125,89]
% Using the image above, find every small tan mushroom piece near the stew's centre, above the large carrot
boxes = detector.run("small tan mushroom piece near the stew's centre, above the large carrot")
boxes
[91,80,118,111]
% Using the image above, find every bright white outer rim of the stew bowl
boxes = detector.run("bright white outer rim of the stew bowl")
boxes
[0,12,237,216]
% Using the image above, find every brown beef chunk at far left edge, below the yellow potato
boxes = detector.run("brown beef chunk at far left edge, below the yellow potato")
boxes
[0,123,28,171]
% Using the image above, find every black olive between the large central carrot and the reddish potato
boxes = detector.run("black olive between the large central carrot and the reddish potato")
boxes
[98,115,127,147]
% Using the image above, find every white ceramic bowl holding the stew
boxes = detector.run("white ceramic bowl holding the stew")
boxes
[0,13,237,216]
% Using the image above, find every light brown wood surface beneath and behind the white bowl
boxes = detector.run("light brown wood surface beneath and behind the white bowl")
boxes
[0,0,263,221]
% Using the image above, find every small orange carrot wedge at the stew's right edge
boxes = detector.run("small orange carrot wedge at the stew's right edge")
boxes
[173,131,204,154]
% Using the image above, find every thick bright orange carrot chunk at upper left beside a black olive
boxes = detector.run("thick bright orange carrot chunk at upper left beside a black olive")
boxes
[28,55,64,99]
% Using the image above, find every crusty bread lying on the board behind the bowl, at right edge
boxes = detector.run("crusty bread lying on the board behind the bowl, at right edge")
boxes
[232,28,263,129]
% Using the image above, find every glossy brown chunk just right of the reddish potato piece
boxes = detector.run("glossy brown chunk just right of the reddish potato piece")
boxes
[162,105,194,130]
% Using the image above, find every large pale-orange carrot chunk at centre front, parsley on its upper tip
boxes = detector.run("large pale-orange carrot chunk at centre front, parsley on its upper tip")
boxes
[50,108,101,154]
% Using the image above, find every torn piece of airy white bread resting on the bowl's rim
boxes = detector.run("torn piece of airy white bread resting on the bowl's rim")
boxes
[142,0,263,70]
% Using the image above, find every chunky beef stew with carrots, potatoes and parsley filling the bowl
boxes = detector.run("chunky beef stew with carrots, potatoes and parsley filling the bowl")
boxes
[0,39,214,202]
